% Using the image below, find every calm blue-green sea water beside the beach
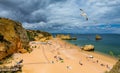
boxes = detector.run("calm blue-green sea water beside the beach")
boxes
[53,34,120,57]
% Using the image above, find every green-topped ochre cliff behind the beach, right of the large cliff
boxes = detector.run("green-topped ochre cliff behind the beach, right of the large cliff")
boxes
[27,30,53,42]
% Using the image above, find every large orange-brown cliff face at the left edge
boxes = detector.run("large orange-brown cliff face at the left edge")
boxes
[0,18,29,60]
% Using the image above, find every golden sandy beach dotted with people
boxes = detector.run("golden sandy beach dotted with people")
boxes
[21,38,117,73]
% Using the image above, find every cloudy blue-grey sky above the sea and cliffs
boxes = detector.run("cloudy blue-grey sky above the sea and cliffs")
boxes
[0,0,120,34]
